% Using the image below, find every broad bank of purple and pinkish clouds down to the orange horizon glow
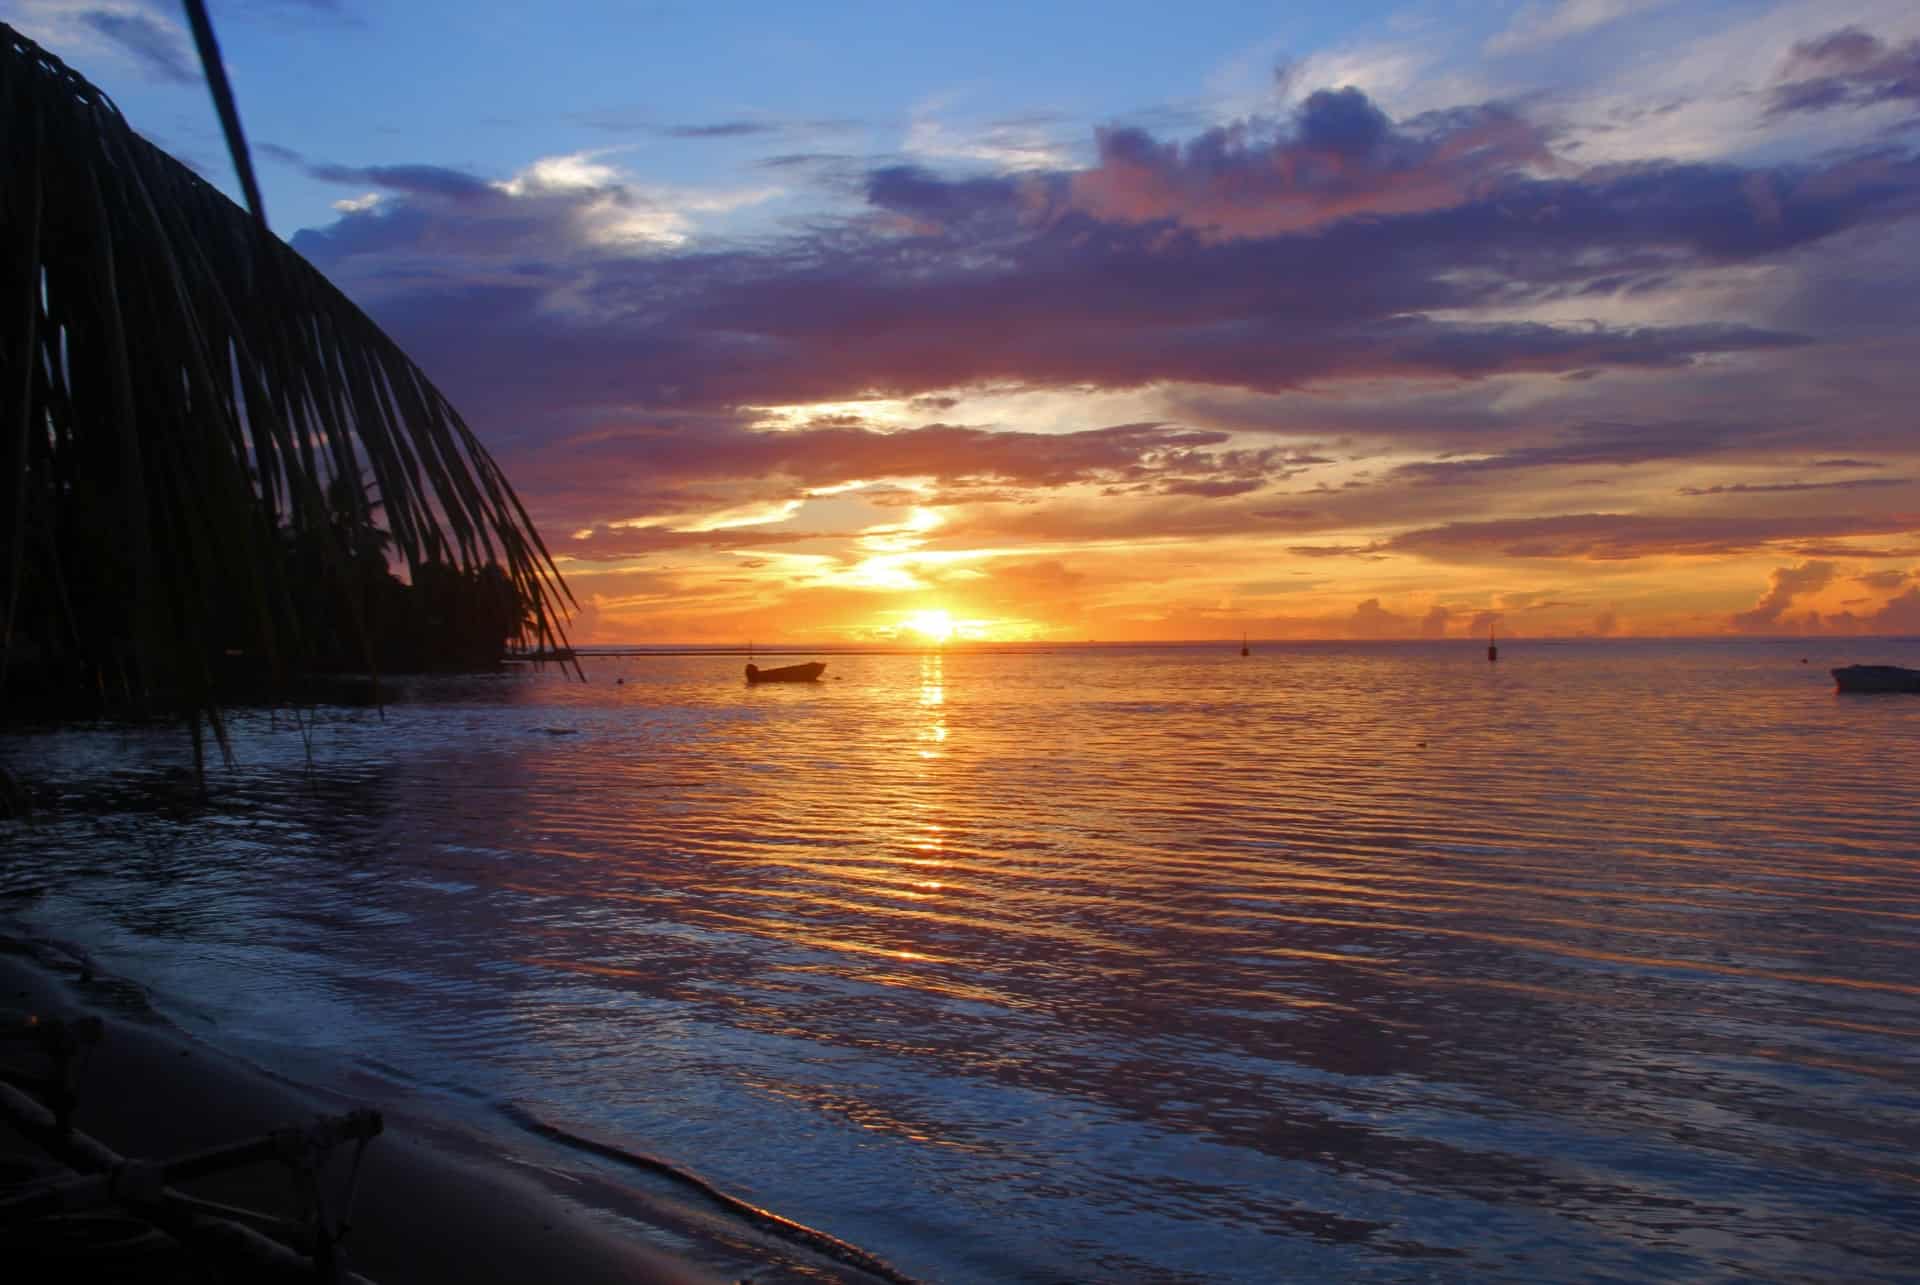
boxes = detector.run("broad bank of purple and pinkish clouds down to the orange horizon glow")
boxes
[270,71,1920,553]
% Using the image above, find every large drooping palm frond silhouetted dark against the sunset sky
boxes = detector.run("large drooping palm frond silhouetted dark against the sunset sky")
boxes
[0,25,572,730]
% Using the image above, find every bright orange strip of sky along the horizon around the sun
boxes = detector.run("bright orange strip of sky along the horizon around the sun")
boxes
[559,478,1920,649]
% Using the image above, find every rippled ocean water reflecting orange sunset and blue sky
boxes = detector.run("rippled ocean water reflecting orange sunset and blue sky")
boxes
[0,640,1920,1281]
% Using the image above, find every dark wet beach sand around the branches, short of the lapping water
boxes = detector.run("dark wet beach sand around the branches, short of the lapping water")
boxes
[0,943,810,1285]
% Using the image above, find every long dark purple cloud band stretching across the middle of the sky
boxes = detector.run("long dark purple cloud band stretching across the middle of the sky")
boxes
[296,88,1920,436]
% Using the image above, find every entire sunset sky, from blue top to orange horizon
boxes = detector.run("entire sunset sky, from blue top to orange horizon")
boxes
[15,0,1920,643]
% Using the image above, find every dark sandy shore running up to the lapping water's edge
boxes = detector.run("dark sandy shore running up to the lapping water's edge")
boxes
[0,930,898,1285]
